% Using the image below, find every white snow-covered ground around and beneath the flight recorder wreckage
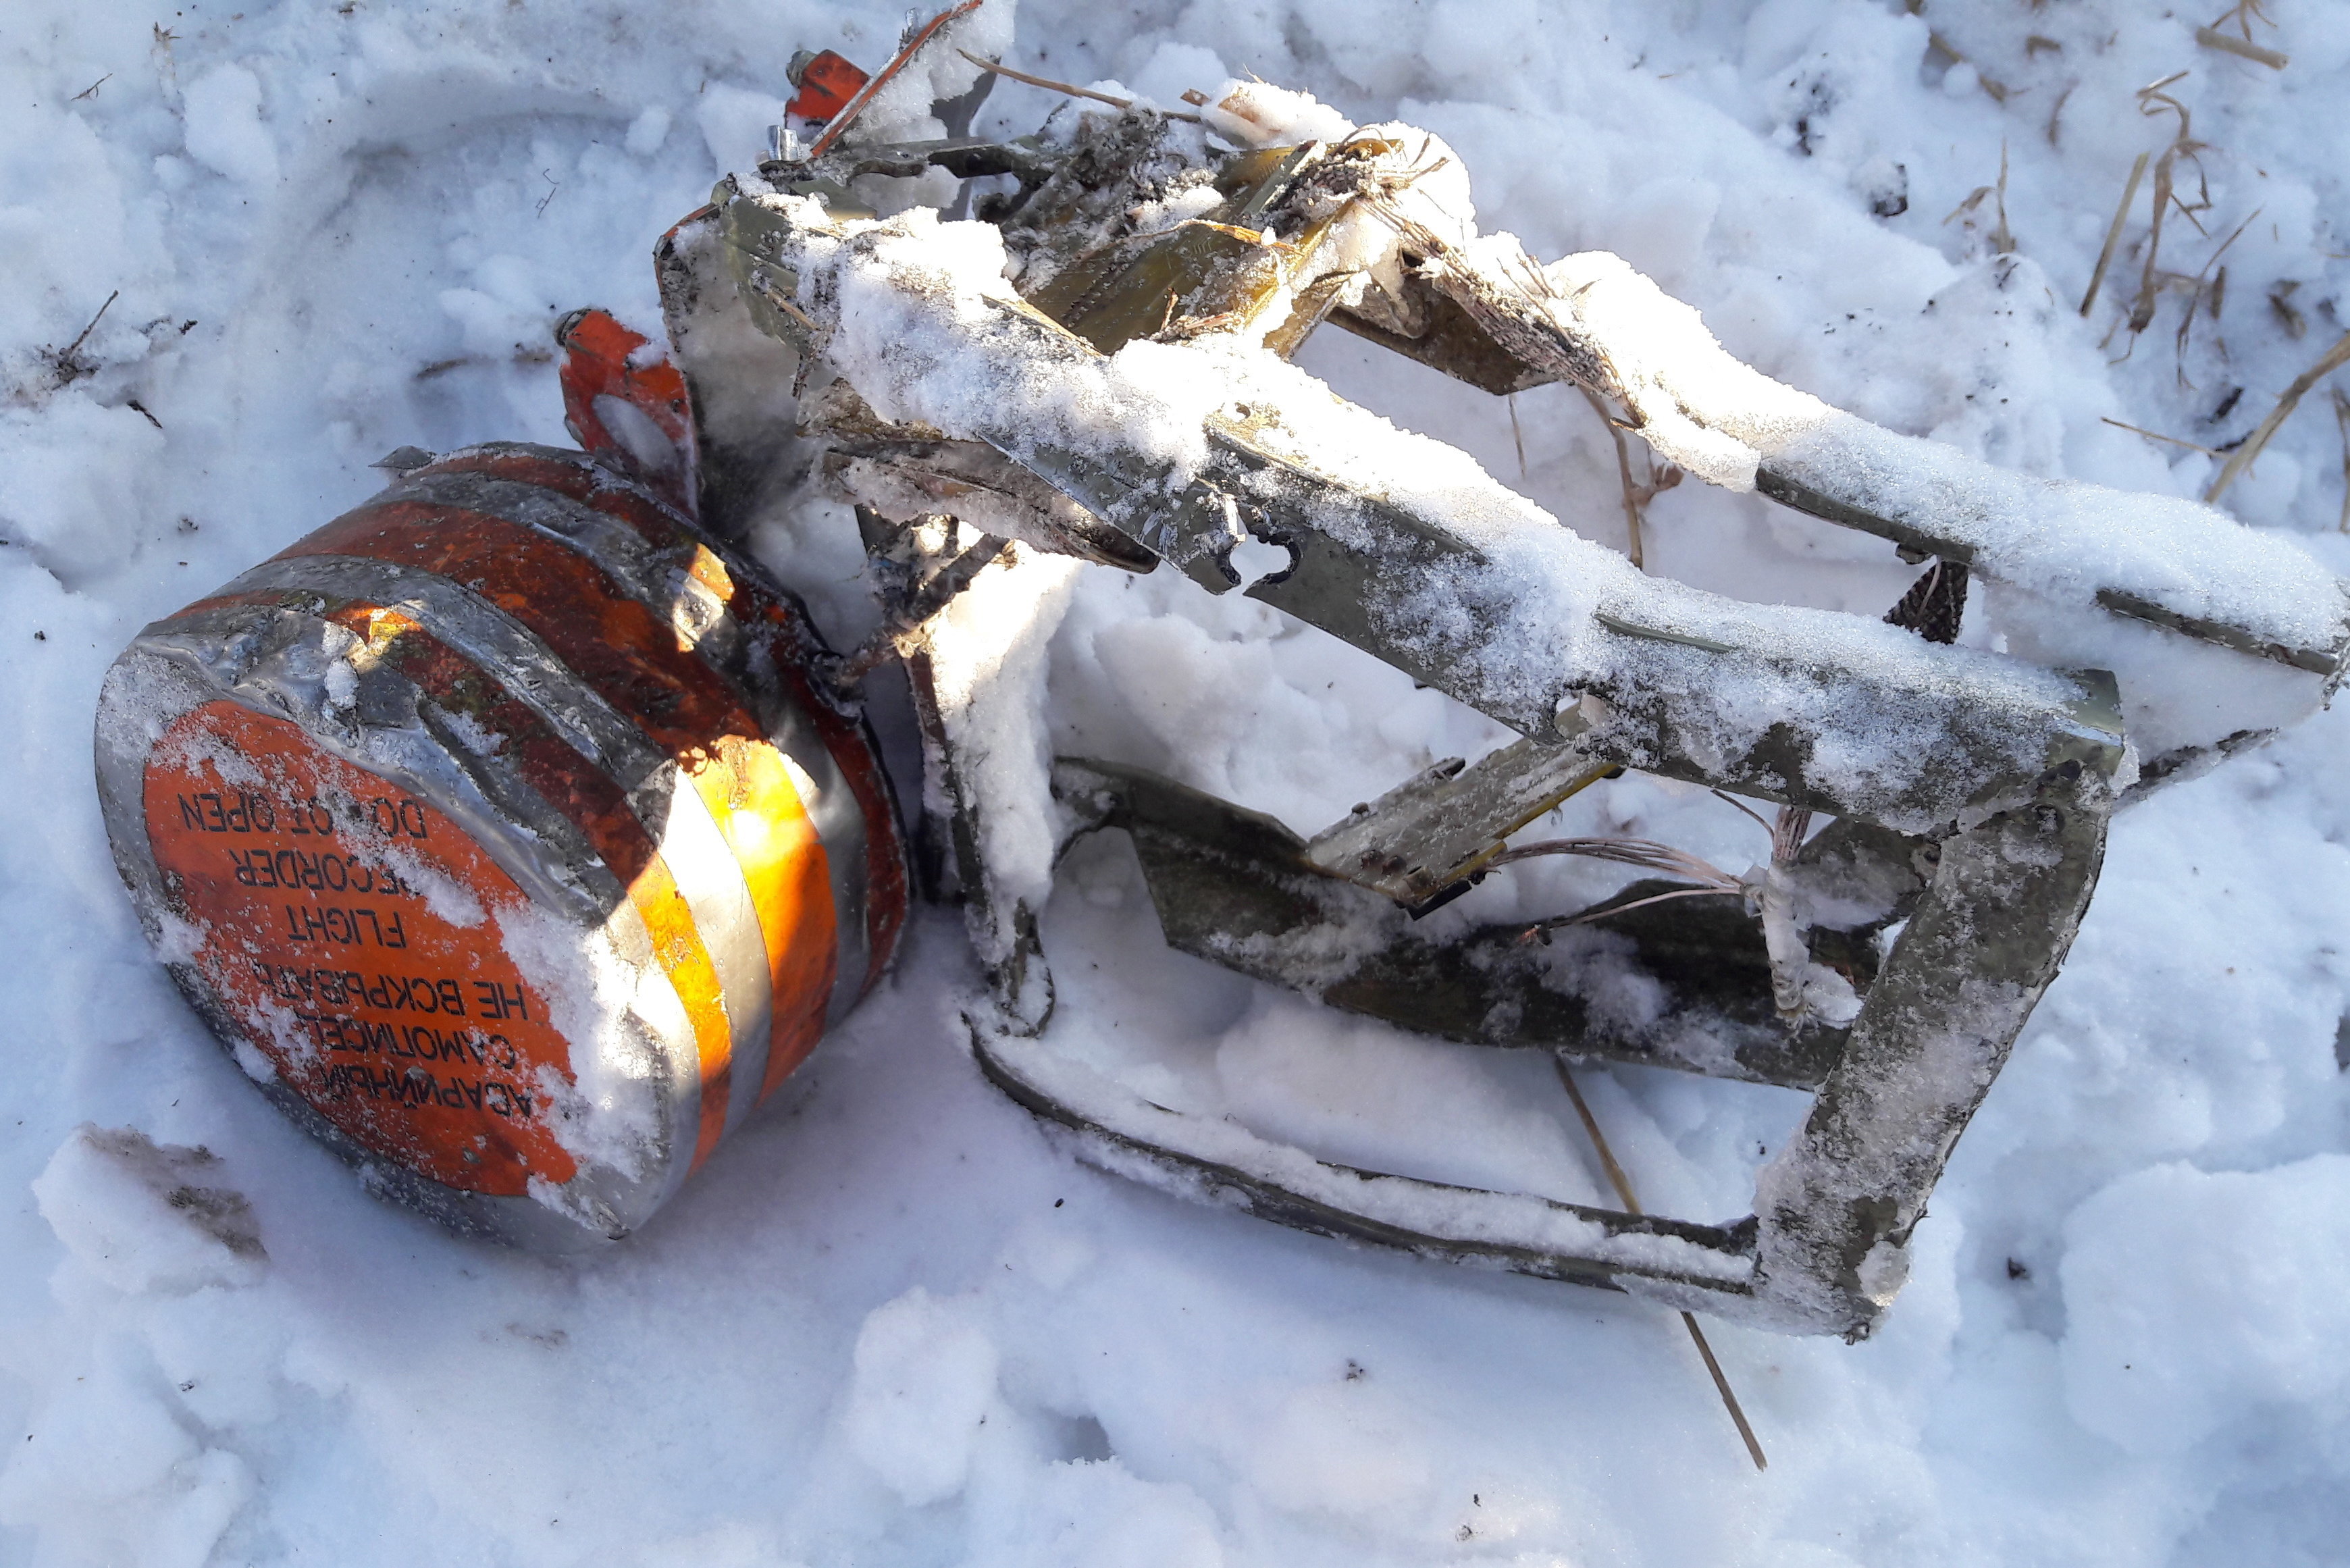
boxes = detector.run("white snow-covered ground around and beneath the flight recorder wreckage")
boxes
[0,0,2350,1568]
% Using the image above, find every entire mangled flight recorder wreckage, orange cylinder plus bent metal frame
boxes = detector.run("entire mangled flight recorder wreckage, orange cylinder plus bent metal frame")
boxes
[99,5,2350,1335]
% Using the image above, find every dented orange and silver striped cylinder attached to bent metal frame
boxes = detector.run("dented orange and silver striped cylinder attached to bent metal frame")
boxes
[97,444,907,1249]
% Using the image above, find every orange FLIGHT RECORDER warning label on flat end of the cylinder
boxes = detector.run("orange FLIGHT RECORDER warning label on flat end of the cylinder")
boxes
[146,703,576,1197]
